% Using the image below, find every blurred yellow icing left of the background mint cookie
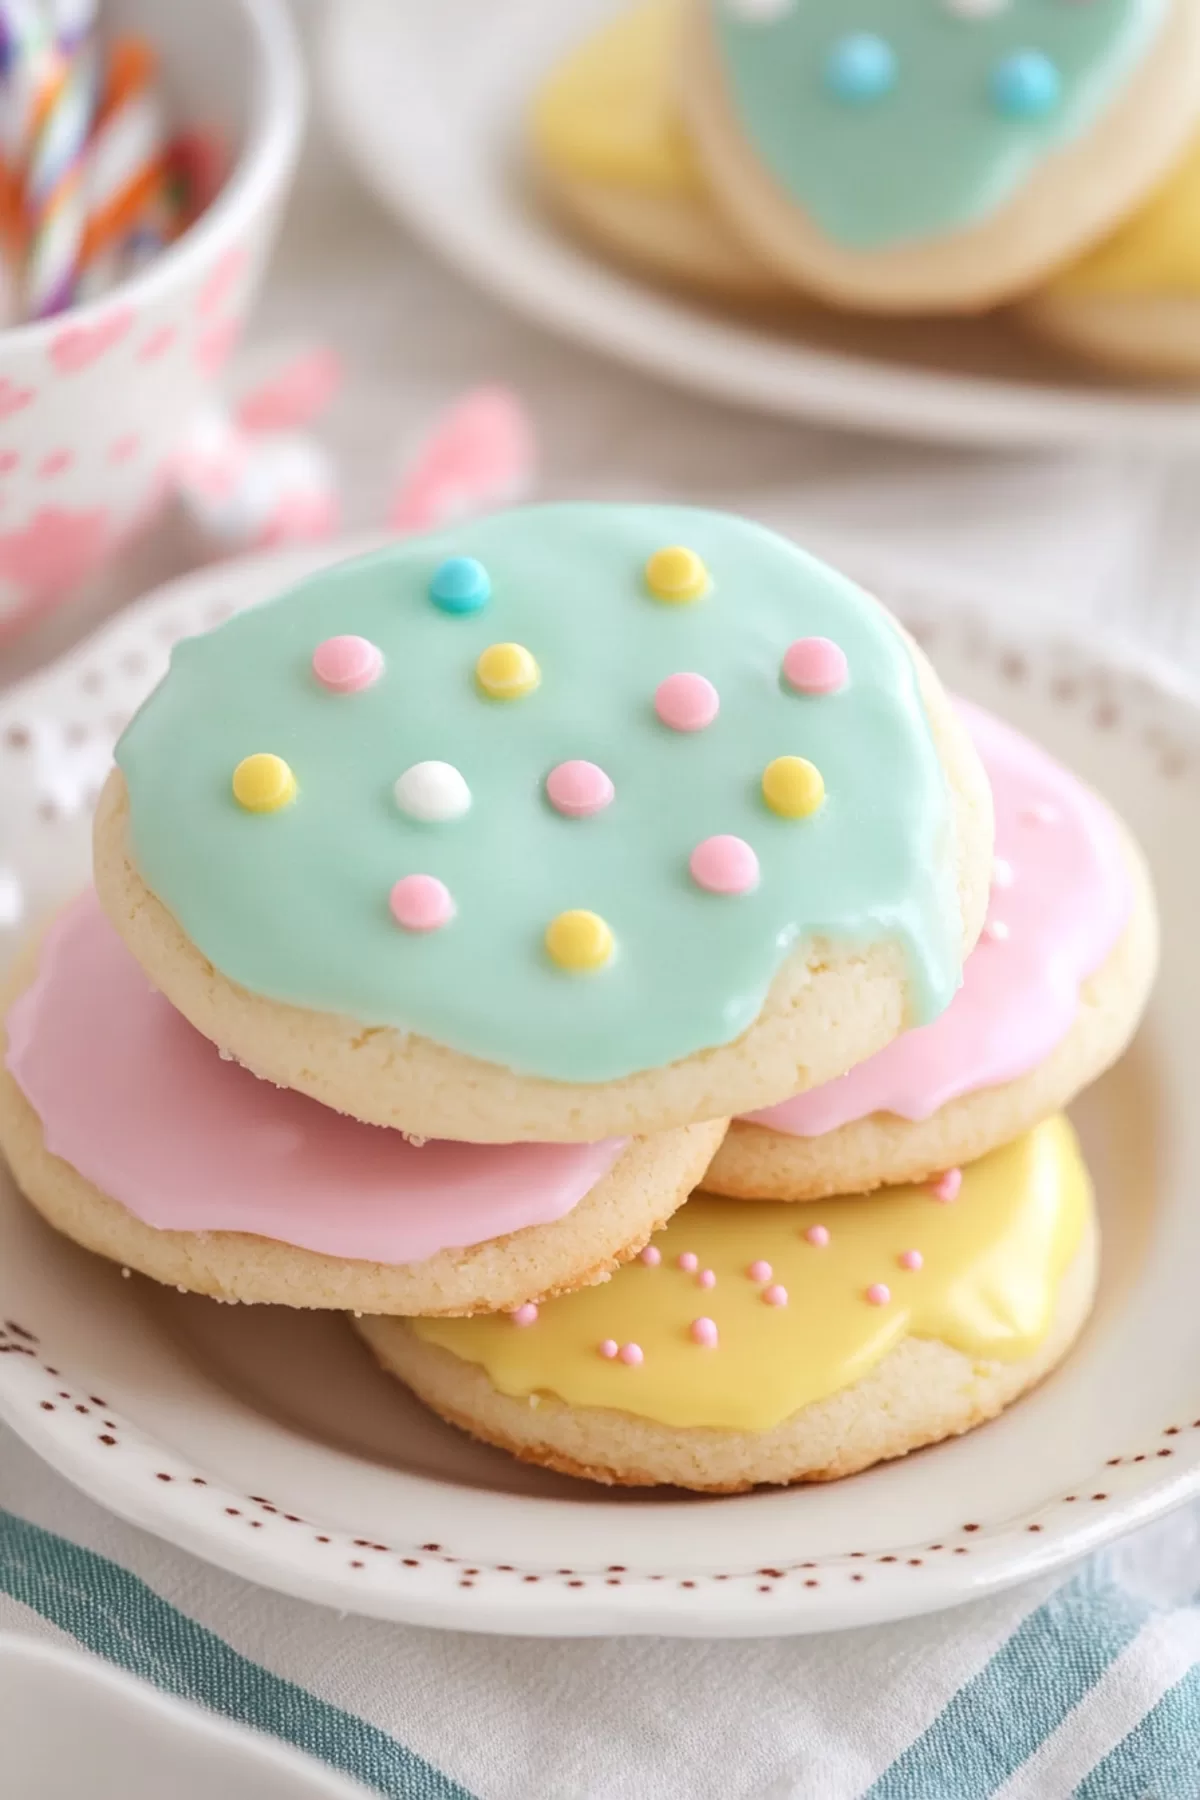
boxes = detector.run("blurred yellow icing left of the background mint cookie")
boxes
[531,0,703,194]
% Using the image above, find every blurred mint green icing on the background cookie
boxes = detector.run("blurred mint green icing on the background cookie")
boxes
[711,0,1165,250]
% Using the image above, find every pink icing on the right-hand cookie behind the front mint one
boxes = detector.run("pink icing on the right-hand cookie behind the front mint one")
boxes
[748,700,1132,1138]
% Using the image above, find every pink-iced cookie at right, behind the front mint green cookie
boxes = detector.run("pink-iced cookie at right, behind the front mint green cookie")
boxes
[703,702,1157,1201]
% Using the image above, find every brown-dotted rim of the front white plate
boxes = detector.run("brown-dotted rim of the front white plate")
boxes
[0,542,1200,1634]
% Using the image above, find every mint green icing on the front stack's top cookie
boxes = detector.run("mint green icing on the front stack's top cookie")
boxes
[117,506,961,1082]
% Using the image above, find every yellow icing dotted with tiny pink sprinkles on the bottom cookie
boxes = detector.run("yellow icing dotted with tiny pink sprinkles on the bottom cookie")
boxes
[410,1114,1092,1431]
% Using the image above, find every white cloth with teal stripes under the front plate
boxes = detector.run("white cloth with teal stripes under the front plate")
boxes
[0,1429,1200,1800]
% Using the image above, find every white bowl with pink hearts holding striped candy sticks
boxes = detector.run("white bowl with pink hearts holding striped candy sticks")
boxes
[0,0,304,635]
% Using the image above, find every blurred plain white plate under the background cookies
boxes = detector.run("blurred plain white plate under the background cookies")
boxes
[318,0,1200,450]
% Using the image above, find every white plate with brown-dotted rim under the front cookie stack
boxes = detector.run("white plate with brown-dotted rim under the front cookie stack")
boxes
[0,529,1200,1636]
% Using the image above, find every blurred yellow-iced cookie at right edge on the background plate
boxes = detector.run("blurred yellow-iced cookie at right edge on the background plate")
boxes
[1016,139,1200,380]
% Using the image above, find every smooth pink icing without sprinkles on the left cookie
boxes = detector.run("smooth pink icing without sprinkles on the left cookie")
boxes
[7,893,624,1264]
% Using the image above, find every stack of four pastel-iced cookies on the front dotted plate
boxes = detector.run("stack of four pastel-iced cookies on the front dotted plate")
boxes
[0,506,1155,1490]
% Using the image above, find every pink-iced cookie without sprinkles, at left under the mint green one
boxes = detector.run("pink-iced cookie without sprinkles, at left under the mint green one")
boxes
[0,893,721,1314]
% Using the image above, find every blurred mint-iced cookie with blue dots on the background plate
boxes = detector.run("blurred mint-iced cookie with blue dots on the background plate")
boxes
[682,0,1200,313]
